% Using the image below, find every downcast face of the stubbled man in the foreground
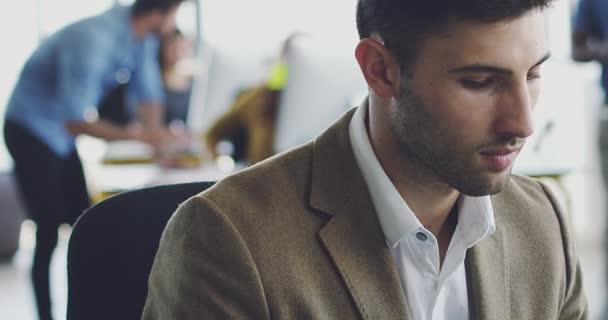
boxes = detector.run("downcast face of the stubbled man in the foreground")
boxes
[390,11,548,196]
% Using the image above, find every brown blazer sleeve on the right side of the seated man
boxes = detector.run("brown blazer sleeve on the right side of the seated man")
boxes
[541,183,589,320]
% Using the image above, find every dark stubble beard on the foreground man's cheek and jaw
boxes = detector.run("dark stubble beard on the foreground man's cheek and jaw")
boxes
[390,85,511,196]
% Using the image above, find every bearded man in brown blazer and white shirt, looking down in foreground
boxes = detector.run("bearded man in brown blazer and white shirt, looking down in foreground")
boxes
[143,0,587,320]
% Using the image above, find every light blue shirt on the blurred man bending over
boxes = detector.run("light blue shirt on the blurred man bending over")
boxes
[6,6,164,157]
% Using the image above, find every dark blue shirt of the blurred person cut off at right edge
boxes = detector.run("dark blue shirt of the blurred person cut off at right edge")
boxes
[573,0,608,99]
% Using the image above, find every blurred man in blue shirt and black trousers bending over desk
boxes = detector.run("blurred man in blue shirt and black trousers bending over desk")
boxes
[4,0,182,319]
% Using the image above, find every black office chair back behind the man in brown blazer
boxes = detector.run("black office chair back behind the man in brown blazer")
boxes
[67,182,213,320]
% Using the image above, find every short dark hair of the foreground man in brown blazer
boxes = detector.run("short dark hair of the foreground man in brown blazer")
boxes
[357,0,554,68]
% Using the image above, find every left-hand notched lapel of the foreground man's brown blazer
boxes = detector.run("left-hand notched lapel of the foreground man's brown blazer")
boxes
[310,110,407,319]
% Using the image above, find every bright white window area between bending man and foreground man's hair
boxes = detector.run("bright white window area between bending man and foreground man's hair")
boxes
[201,0,357,48]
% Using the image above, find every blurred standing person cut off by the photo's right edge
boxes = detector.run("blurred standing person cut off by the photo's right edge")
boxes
[572,0,608,317]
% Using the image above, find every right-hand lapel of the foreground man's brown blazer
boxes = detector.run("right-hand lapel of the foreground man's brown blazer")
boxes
[465,198,511,320]
